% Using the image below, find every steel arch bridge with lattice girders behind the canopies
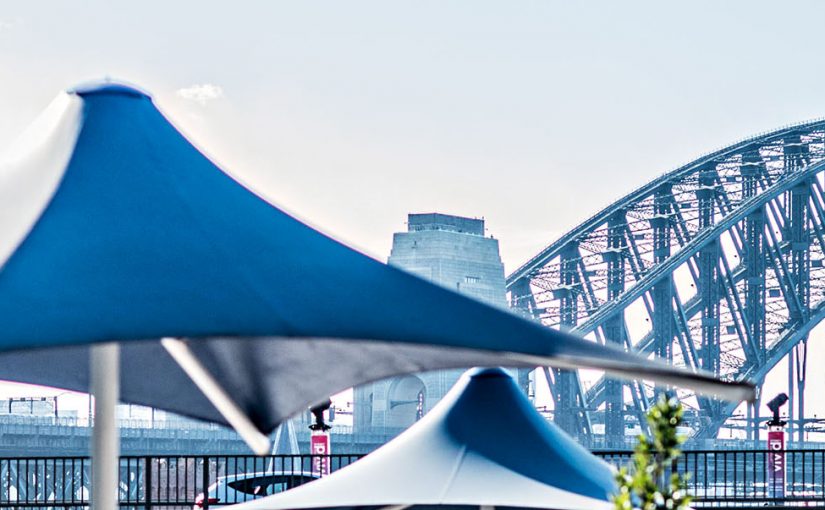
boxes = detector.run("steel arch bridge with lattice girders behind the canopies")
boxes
[507,120,825,445]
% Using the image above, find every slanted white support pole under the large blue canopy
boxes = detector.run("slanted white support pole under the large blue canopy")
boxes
[160,338,271,456]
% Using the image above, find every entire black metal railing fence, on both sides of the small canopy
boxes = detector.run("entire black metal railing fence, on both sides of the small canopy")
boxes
[0,450,825,509]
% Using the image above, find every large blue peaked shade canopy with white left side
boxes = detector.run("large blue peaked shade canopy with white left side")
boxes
[0,83,753,432]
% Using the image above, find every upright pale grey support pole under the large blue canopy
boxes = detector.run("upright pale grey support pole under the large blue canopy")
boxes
[89,343,120,510]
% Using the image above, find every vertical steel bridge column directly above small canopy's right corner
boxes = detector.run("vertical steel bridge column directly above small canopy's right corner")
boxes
[604,211,627,448]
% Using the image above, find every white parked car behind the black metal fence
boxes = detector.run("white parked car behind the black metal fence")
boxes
[193,471,318,510]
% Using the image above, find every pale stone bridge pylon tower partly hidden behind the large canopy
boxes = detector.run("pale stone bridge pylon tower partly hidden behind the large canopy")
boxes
[353,213,507,435]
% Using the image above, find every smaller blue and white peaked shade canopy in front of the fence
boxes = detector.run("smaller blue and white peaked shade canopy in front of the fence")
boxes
[238,369,616,510]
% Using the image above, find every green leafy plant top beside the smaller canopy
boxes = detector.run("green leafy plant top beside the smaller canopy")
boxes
[613,396,692,510]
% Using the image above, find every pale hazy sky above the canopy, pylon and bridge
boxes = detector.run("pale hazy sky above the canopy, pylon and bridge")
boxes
[0,0,825,430]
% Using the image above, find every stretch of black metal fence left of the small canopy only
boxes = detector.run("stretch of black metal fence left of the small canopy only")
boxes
[0,454,361,510]
